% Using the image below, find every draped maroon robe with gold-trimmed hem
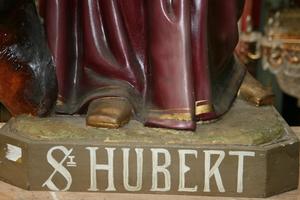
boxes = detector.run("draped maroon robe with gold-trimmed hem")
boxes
[39,0,244,130]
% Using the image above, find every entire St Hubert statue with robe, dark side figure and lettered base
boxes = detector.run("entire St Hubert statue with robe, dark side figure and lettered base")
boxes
[0,0,299,197]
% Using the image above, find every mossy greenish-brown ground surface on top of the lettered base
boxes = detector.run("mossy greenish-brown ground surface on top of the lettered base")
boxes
[5,100,284,145]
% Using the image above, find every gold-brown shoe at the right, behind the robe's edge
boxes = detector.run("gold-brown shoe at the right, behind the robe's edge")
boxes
[239,72,274,106]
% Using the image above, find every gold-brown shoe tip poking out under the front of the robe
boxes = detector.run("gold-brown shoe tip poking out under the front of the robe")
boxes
[86,97,133,128]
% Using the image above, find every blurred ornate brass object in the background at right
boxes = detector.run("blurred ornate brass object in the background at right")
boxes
[237,8,300,105]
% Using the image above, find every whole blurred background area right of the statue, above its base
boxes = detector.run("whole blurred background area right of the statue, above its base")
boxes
[236,0,300,126]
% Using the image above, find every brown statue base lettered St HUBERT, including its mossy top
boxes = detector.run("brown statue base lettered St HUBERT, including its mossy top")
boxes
[0,100,299,197]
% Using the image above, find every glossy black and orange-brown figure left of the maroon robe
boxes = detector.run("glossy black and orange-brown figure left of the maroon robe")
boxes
[0,0,57,119]
